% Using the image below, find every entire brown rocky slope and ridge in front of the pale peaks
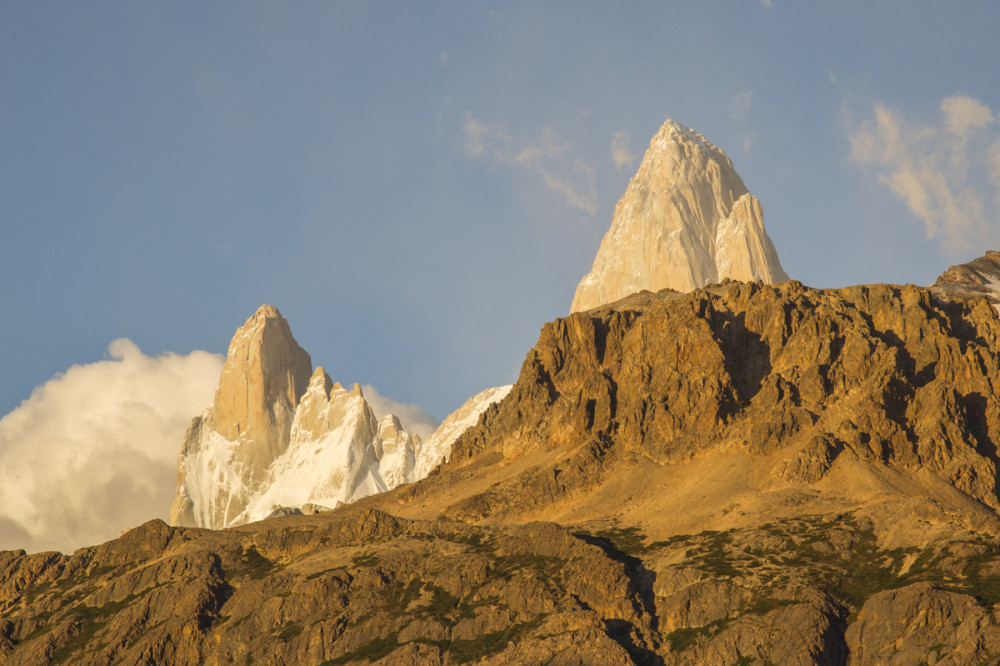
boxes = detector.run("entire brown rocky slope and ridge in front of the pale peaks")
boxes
[0,274,1000,664]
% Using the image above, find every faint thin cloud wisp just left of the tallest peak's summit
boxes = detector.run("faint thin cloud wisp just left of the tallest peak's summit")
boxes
[462,115,597,215]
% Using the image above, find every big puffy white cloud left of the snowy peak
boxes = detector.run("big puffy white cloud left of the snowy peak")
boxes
[0,338,223,552]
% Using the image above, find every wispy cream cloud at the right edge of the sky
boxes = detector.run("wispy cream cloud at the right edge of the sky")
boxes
[850,95,1000,254]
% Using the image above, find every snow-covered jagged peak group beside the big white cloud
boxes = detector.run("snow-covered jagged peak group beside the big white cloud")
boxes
[170,305,502,529]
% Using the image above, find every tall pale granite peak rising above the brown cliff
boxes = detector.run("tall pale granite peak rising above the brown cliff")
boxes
[570,120,788,312]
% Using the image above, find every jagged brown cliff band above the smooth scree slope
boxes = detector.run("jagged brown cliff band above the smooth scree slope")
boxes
[448,282,1000,520]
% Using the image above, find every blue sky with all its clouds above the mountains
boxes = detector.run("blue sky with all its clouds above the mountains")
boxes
[0,0,1000,548]
